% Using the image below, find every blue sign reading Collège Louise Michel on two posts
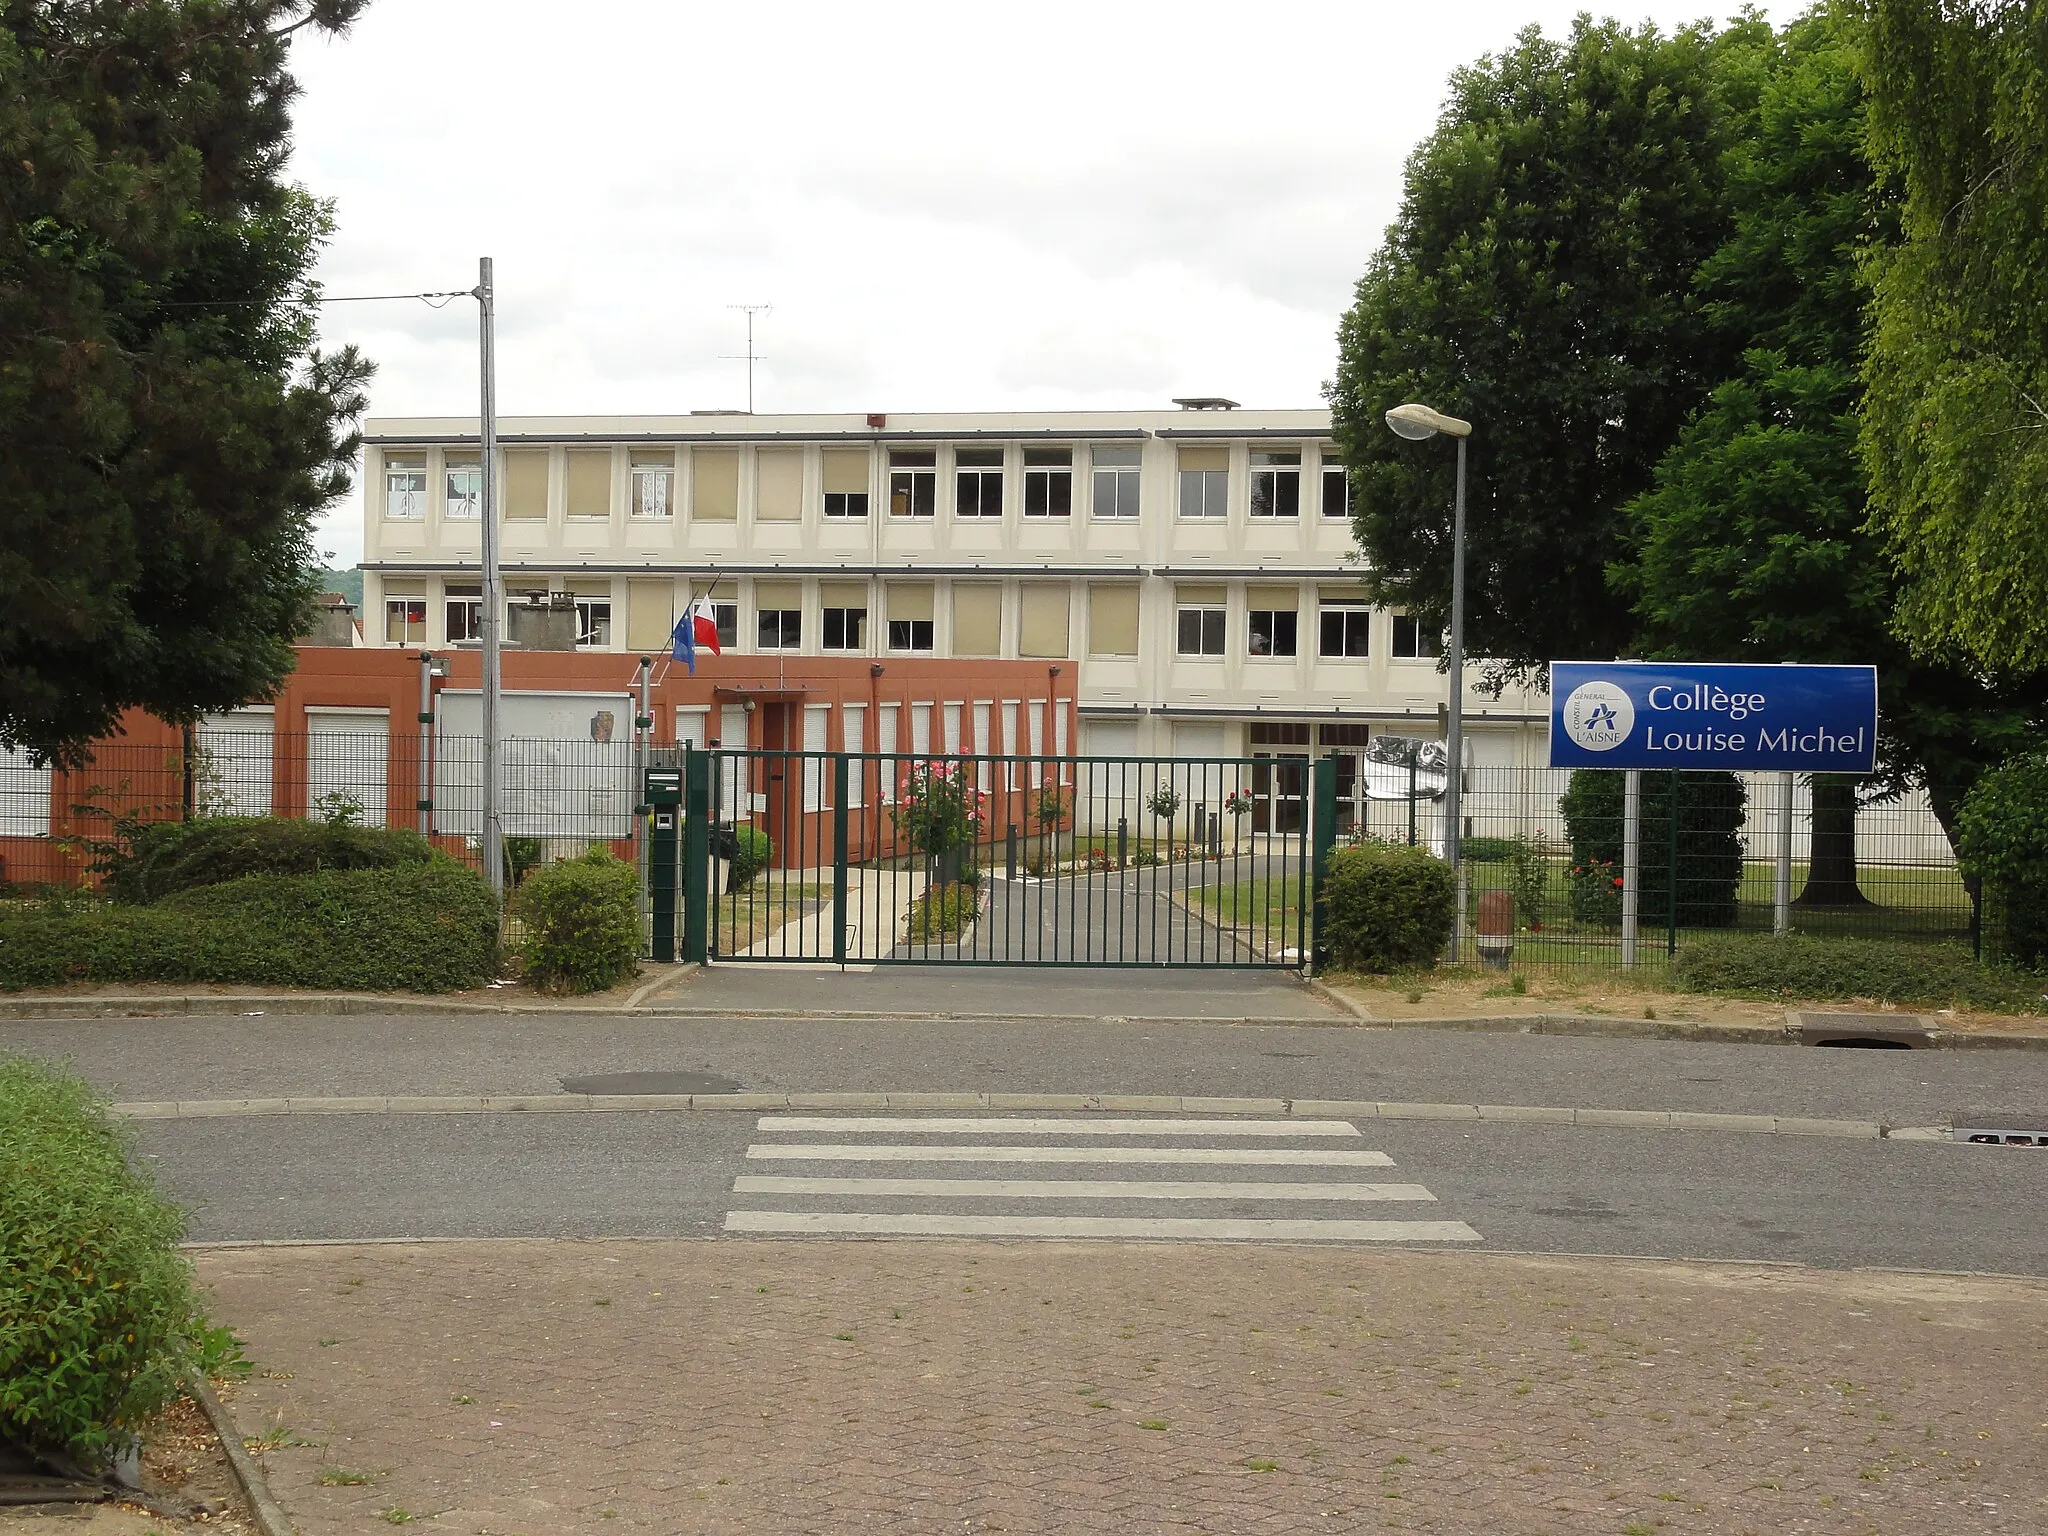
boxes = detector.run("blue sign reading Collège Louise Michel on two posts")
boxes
[1550,662,1878,774]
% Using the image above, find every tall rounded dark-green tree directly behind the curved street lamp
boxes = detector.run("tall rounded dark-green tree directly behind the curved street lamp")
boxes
[1329,18,1772,672]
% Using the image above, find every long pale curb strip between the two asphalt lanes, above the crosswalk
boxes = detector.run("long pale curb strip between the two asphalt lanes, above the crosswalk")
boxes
[113,1092,1916,1141]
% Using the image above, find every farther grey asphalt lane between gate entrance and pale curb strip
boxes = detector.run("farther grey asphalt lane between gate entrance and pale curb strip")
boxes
[16,1003,2048,1124]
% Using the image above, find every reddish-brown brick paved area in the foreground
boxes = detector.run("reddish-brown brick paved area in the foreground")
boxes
[199,1241,2048,1536]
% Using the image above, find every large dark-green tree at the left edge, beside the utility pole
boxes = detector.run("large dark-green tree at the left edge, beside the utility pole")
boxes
[0,0,369,758]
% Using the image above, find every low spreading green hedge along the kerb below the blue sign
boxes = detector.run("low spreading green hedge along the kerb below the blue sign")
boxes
[1671,934,2044,1014]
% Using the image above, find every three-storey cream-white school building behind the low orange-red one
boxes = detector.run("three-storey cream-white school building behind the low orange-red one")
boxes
[365,401,1544,823]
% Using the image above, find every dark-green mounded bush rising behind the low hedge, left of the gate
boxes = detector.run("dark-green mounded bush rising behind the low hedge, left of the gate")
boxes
[106,815,434,901]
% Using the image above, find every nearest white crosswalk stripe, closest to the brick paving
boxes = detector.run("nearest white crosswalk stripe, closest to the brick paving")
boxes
[725,1210,1481,1243]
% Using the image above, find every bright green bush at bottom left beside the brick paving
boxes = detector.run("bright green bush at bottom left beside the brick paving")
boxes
[0,1057,203,1468]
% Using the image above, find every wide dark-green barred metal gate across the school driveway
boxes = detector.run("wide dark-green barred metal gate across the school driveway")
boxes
[682,750,1335,969]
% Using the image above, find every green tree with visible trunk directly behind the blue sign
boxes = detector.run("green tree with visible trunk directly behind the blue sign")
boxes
[1610,10,2044,888]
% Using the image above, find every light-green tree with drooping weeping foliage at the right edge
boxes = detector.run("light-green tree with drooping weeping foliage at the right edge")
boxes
[1858,0,2048,672]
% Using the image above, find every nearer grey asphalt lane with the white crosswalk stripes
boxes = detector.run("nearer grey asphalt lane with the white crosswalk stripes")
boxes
[139,1114,2048,1274]
